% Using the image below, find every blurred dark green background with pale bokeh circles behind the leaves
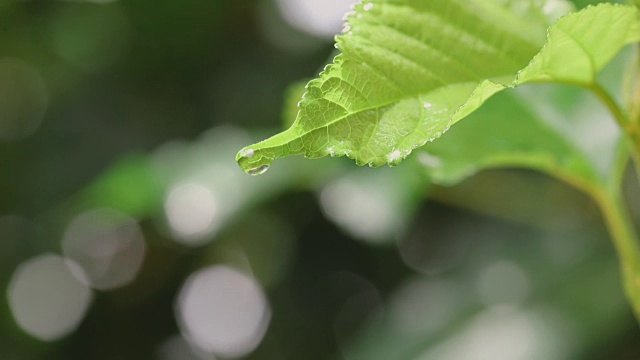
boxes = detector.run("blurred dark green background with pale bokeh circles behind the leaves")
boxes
[0,0,640,360]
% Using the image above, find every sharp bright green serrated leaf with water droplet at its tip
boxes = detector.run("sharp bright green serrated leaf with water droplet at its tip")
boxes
[236,0,640,173]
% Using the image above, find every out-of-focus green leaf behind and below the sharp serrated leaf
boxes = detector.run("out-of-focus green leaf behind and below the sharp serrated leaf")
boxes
[414,49,634,192]
